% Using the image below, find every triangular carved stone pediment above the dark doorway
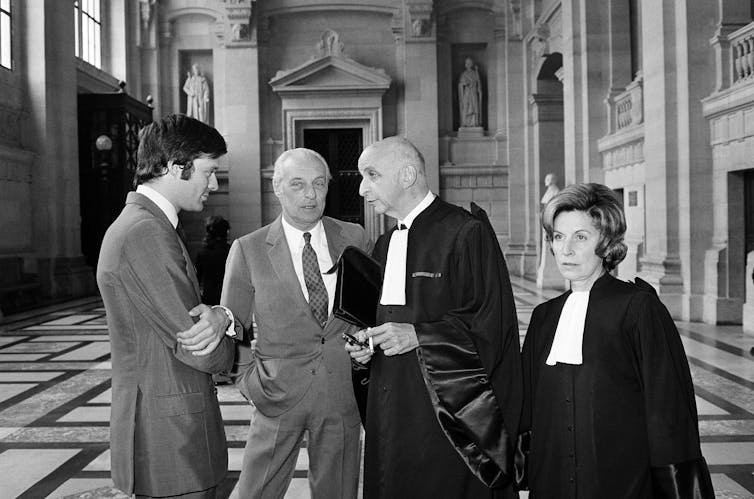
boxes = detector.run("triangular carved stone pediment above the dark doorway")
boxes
[270,55,390,93]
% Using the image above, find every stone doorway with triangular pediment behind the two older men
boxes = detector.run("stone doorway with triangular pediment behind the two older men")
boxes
[270,30,391,240]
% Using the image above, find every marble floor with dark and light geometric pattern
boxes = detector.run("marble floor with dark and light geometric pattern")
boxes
[0,280,754,499]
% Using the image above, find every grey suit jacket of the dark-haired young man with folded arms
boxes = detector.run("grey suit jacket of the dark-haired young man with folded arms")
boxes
[97,192,235,496]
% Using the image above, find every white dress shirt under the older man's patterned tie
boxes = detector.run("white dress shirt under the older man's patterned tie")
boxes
[282,217,338,315]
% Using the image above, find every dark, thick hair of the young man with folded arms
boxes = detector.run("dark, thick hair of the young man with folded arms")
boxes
[134,114,228,186]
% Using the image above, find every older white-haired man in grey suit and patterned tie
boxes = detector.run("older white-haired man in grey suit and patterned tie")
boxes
[220,148,371,499]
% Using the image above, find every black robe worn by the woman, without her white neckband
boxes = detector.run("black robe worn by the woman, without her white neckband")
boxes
[521,274,714,499]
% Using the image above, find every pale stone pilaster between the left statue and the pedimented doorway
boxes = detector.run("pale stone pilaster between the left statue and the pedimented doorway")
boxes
[214,1,262,237]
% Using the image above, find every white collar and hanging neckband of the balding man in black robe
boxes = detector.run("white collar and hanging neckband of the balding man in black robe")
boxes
[380,191,435,305]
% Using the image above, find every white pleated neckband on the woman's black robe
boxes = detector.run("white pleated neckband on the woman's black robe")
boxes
[545,291,589,366]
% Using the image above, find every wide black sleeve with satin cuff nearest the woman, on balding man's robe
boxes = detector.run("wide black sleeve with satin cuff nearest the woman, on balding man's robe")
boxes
[406,219,522,487]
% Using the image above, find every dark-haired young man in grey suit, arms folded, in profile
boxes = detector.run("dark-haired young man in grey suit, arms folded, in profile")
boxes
[97,115,235,498]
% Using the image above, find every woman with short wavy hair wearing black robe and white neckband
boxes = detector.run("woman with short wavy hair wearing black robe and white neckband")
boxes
[521,184,714,499]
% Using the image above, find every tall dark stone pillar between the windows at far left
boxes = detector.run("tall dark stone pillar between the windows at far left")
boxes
[19,0,96,297]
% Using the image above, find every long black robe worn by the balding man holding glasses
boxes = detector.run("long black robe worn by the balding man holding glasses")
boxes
[364,198,523,499]
